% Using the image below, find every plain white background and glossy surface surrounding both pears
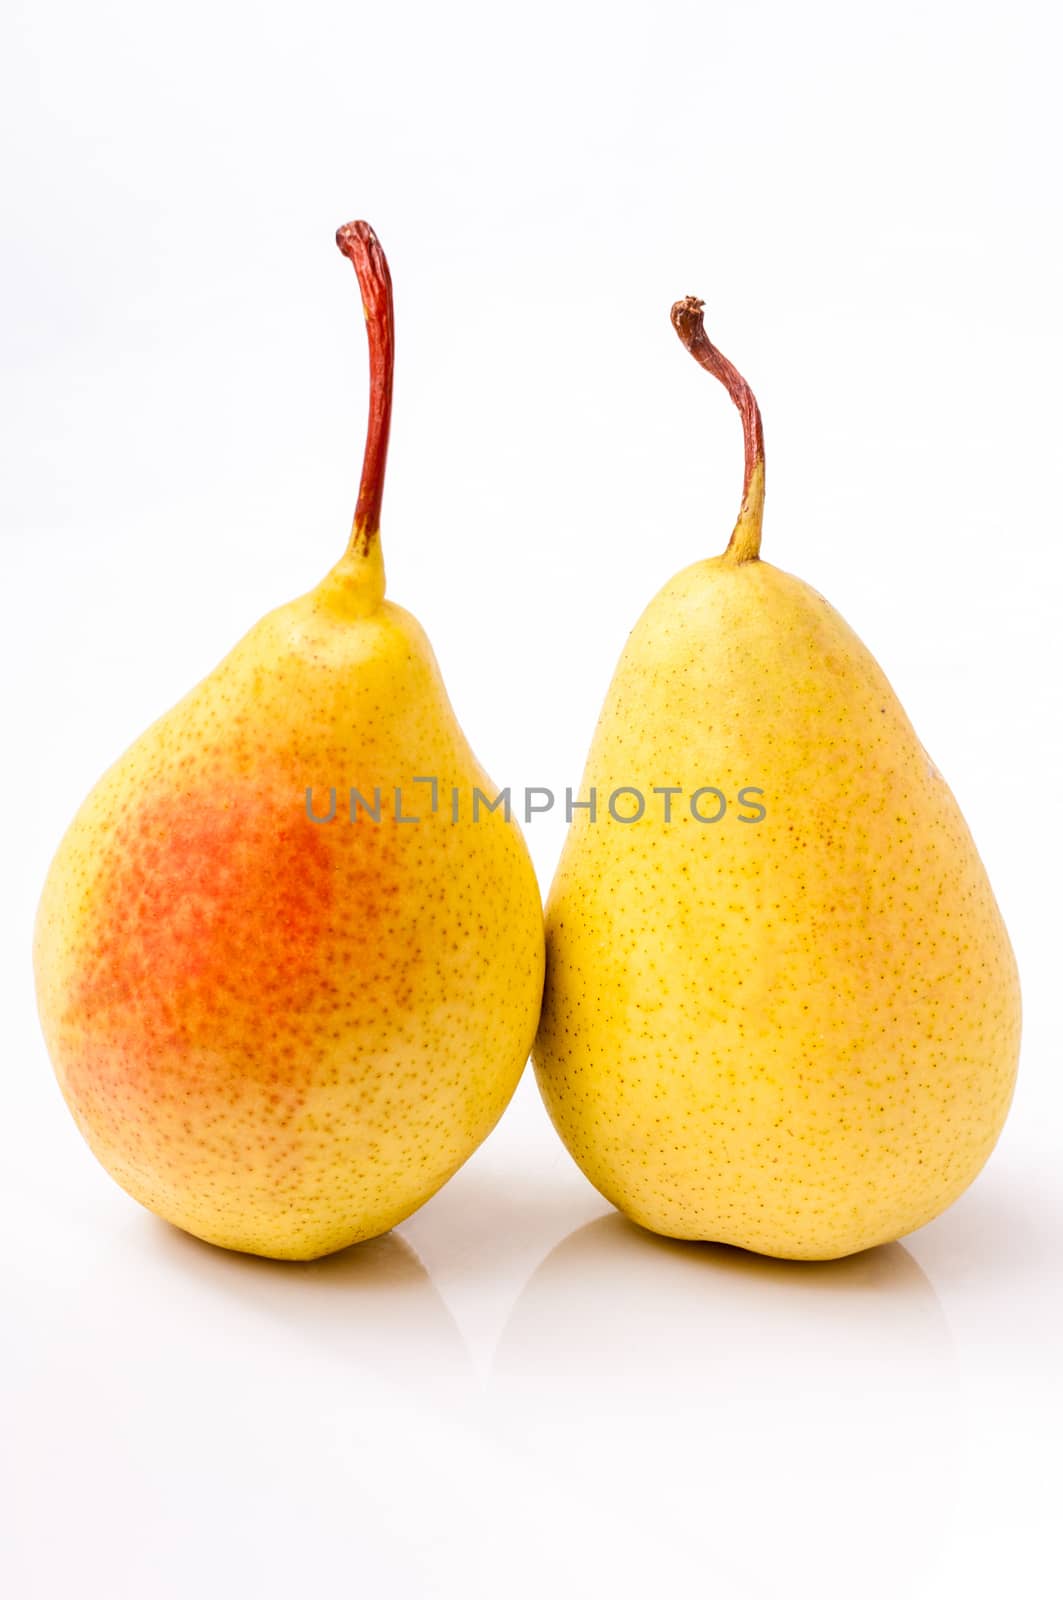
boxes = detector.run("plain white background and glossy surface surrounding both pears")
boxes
[0,0,1063,1600]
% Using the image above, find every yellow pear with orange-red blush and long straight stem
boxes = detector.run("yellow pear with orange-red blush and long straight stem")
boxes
[35,222,543,1259]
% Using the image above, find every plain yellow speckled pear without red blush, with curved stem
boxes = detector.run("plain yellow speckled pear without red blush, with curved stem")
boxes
[533,299,1020,1259]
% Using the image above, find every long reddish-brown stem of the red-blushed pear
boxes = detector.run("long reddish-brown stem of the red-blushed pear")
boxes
[336,222,395,555]
